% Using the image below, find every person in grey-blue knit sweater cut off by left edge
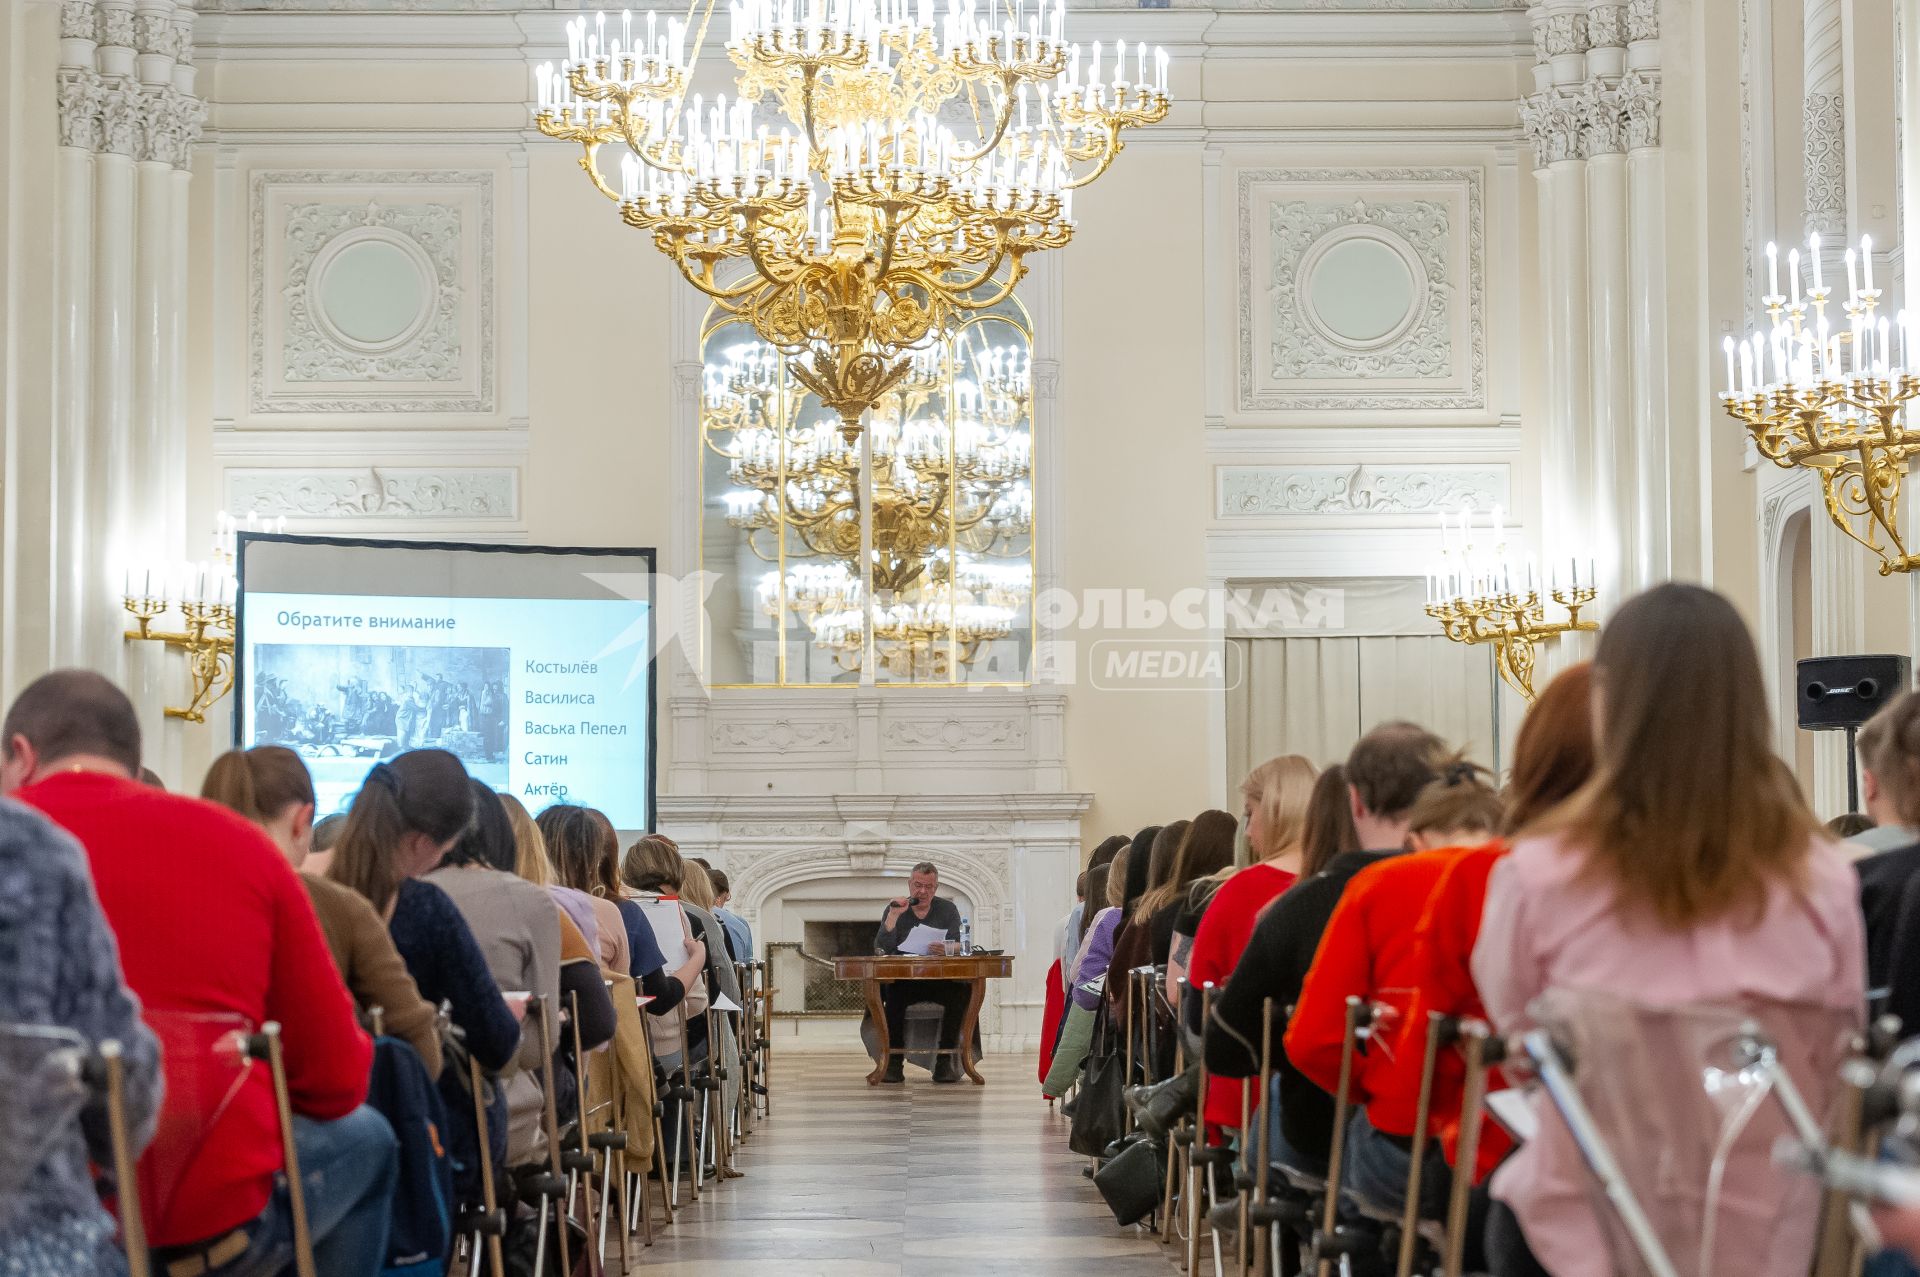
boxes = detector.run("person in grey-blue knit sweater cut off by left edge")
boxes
[0,799,159,1277]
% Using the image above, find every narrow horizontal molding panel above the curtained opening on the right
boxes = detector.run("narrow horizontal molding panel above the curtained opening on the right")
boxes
[1215,463,1511,520]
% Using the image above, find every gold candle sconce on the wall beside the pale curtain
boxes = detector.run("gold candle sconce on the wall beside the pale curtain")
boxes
[1427,505,1599,705]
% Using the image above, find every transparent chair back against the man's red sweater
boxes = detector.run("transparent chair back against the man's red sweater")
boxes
[138,1006,255,1227]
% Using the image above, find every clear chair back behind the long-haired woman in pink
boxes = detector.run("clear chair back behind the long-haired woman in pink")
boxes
[1528,989,1857,1277]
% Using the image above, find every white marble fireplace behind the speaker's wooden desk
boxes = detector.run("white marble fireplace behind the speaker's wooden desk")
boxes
[660,682,1089,1050]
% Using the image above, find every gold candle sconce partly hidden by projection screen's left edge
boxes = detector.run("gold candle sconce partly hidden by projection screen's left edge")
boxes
[121,511,286,722]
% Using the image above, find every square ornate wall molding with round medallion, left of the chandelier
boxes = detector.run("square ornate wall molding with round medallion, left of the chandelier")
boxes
[248,169,499,417]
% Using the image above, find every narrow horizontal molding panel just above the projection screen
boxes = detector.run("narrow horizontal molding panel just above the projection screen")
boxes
[225,467,520,522]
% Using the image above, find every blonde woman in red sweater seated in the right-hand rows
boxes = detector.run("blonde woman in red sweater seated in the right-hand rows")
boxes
[1167,755,1320,1125]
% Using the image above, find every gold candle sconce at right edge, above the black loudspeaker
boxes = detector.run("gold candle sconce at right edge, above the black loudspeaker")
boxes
[1720,234,1920,576]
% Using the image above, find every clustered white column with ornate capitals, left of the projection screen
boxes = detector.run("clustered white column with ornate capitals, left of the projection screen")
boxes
[44,0,202,737]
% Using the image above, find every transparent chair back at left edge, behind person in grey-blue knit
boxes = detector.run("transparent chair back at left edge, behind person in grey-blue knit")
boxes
[0,1024,90,1235]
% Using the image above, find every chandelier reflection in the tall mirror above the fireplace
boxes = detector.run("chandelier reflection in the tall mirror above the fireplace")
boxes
[701,324,1033,680]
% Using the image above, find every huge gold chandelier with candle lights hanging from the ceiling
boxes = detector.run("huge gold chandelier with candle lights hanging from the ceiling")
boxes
[536,0,1167,433]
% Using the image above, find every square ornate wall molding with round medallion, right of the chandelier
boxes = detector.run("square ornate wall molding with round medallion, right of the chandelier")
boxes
[1236,167,1488,413]
